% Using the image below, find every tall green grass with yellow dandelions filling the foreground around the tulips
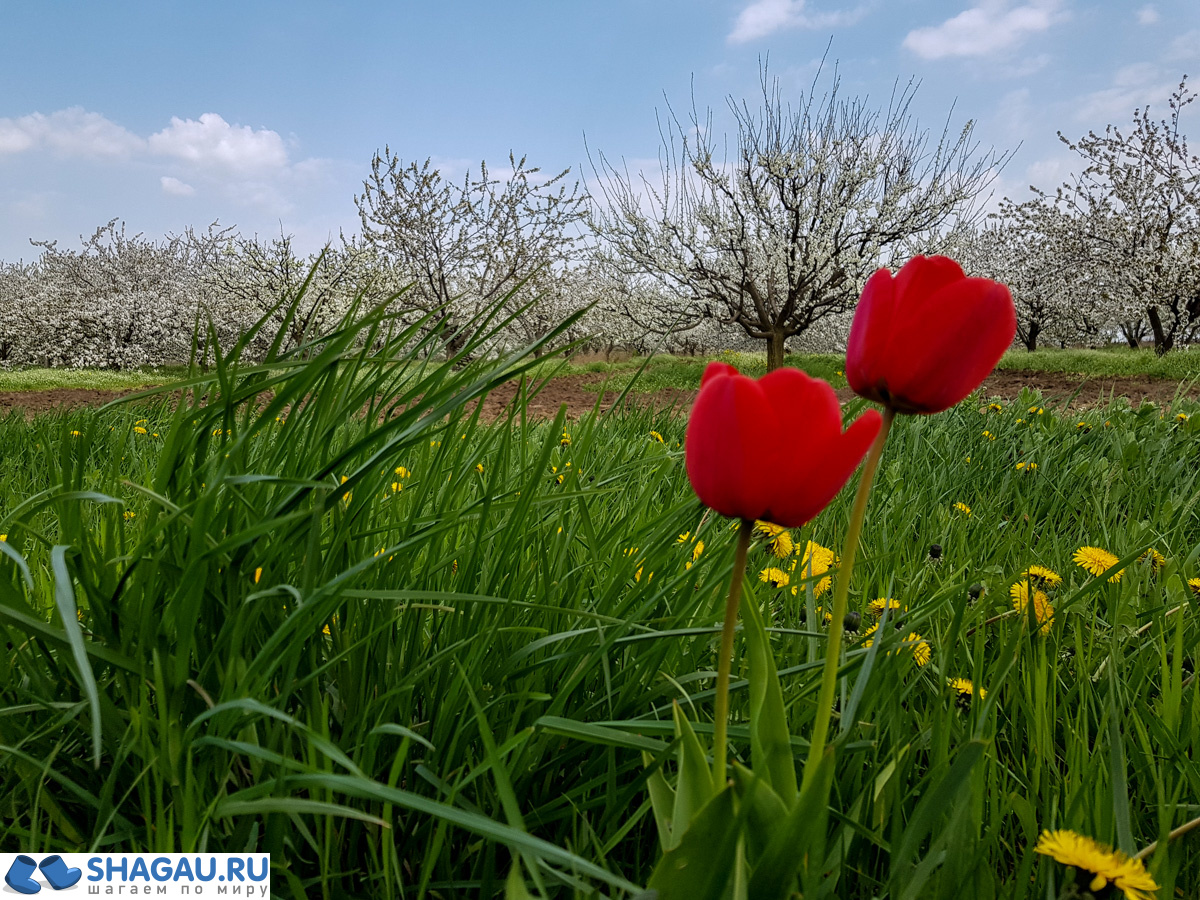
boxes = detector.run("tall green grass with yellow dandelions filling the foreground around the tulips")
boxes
[0,307,1200,900]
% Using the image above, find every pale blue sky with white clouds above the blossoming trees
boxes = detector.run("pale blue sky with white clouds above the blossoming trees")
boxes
[0,0,1200,262]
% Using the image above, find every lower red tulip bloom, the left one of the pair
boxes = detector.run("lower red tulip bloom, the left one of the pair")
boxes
[685,362,882,528]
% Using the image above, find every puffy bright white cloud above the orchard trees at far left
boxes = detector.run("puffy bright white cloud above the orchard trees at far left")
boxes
[149,113,288,174]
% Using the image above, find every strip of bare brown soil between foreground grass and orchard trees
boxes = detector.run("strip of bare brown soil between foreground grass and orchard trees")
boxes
[0,371,1200,420]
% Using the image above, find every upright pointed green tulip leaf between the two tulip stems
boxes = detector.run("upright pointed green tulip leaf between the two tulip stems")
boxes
[743,600,797,806]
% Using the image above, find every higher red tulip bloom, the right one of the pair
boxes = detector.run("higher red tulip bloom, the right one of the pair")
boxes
[846,257,1016,413]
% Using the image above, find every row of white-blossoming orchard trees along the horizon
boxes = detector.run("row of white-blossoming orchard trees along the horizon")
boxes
[0,71,1200,368]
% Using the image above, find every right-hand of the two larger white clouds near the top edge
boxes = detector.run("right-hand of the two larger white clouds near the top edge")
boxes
[904,0,1066,59]
